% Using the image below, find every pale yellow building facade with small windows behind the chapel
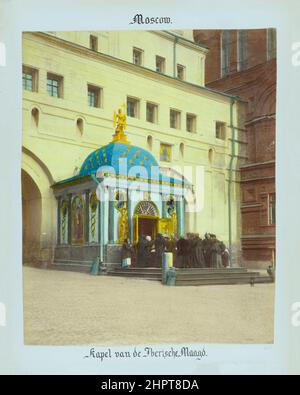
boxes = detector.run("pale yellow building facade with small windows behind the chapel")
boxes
[22,31,246,263]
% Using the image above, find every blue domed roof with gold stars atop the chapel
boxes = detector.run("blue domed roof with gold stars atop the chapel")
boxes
[79,142,159,176]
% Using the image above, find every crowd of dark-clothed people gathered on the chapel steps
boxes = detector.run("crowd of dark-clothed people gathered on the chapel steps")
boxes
[122,233,230,268]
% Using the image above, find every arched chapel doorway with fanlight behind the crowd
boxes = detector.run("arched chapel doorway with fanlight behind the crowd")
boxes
[134,201,159,242]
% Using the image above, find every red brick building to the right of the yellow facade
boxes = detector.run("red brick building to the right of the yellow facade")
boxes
[194,29,276,266]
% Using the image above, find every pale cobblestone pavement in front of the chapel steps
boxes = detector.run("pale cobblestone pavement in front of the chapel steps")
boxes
[23,267,274,345]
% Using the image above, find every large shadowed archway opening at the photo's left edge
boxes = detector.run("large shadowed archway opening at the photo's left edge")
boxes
[22,170,42,265]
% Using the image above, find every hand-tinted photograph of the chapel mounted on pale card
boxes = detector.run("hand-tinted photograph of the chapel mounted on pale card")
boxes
[22,28,276,346]
